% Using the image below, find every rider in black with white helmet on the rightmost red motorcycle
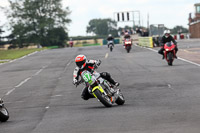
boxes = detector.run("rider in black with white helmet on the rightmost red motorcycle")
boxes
[158,30,178,59]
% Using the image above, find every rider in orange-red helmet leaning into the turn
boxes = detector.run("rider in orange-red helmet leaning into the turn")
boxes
[73,55,119,100]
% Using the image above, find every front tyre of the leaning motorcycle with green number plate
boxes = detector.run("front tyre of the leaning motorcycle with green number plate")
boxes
[93,89,112,107]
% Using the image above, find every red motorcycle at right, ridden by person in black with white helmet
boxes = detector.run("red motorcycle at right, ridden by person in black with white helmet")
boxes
[164,42,176,66]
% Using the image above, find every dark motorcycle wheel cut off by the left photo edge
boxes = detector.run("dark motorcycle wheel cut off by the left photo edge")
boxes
[0,98,9,122]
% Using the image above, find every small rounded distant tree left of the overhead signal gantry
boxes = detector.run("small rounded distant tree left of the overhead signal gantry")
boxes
[87,18,117,36]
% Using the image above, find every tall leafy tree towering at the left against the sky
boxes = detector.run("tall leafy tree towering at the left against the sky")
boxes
[8,0,71,46]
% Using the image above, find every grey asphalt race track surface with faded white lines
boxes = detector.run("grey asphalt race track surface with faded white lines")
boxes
[0,40,200,133]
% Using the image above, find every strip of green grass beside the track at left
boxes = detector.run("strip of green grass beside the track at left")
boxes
[0,48,46,62]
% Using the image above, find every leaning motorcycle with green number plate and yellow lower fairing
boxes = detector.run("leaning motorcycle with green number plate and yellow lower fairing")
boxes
[78,66,125,107]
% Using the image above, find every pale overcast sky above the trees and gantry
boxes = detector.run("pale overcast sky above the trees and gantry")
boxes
[0,0,200,36]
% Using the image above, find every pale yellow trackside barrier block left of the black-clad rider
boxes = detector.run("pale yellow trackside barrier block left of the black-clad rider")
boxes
[139,37,153,48]
